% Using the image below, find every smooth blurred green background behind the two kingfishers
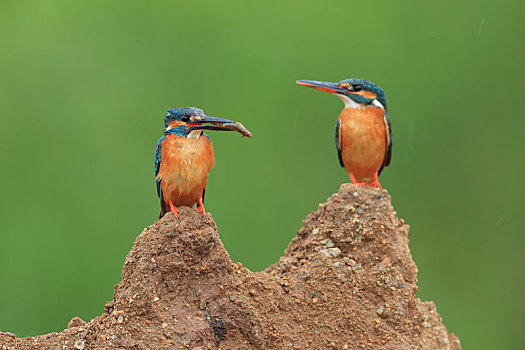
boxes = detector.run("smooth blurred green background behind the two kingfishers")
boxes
[0,0,525,349]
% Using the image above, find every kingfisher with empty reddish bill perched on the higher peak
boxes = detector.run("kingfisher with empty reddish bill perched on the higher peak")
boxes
[297,79,392,188]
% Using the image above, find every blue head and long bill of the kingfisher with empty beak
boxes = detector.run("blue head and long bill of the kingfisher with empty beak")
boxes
[297,79,386,110]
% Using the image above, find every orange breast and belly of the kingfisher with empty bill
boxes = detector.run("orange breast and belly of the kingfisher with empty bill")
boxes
[339,107,388,183]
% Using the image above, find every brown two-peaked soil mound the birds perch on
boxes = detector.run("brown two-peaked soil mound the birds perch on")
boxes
[0,184,461,350]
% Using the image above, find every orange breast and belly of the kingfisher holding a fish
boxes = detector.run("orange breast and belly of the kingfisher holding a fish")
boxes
[157,135,215,207]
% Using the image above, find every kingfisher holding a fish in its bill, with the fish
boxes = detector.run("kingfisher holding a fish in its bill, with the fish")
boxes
[155,107,252,219]
